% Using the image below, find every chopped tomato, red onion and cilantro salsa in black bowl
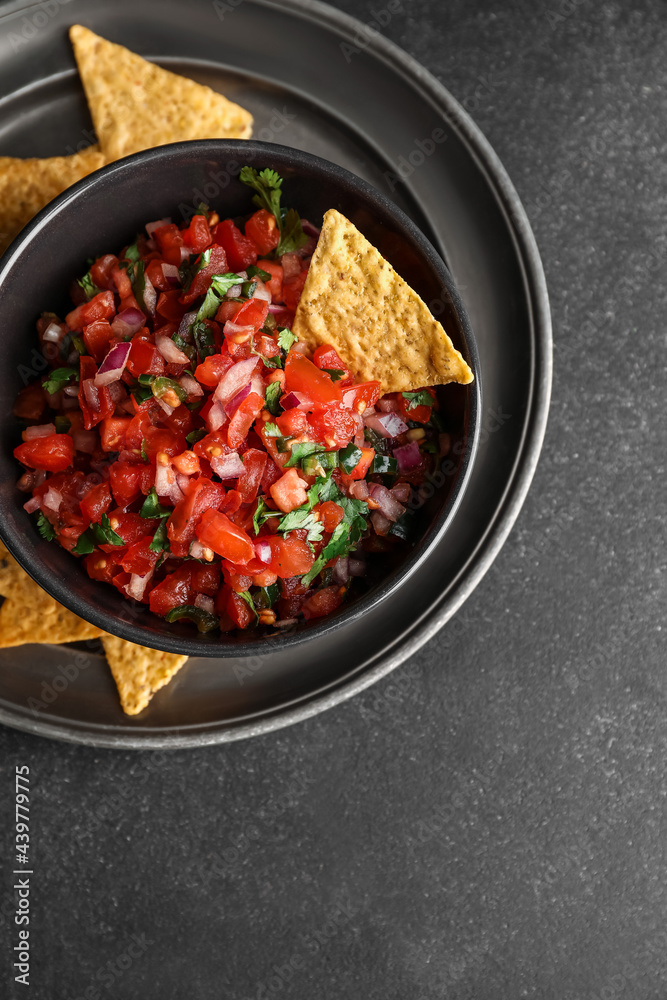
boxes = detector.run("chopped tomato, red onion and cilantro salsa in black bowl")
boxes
[14,167,449,631]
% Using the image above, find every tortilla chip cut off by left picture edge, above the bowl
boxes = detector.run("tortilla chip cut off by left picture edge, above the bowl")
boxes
[0,146,104,253]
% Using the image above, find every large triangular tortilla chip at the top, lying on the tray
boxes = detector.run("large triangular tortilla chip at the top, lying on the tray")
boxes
[69,24,252,160]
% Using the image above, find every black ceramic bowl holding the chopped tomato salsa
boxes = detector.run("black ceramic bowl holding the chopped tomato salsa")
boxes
[0,140,480,657]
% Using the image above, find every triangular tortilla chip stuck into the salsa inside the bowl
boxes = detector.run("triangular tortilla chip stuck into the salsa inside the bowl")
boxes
[292,209,473,392]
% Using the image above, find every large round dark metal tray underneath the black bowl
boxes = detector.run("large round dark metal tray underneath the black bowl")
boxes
[0,0,551,748]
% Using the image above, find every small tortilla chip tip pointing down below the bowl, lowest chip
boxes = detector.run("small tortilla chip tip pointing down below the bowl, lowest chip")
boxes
[102,634,187,715]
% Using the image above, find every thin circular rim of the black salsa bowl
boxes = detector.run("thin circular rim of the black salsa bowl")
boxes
[0,139,482,659]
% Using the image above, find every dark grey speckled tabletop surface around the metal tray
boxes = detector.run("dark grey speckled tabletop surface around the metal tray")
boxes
[0,0,667,1000]
